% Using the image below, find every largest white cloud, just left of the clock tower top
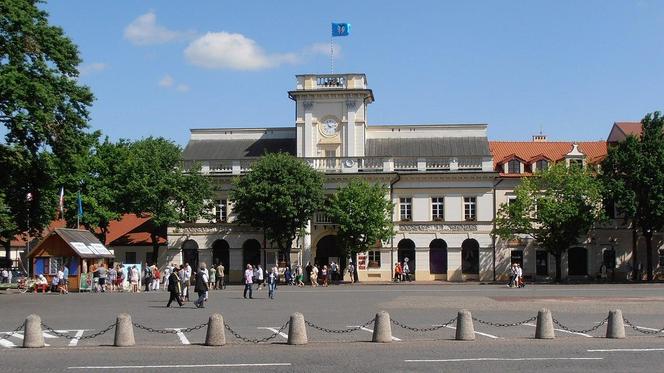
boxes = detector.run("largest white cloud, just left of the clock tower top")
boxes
[184,32,300,70]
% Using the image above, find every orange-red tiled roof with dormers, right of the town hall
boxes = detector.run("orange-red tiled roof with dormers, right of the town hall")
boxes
[489,141,607,177]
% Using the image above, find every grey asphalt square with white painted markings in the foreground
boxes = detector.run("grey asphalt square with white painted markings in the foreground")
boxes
[0,284,664,372]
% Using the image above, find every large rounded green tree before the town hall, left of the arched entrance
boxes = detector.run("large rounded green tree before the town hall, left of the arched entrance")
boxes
[230,153,323,260]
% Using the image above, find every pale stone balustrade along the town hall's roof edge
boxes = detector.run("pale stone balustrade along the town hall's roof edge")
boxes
[185,157,493,175]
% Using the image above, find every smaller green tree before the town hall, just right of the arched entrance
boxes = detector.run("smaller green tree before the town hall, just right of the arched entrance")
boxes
[325,179,394,262]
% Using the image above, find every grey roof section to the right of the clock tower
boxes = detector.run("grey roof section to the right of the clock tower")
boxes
[365,137,491,157]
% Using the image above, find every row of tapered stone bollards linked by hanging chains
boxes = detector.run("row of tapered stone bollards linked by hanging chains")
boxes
[11,308,664,348]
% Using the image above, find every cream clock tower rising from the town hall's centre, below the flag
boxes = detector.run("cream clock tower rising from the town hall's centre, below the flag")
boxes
[288,74,374,158]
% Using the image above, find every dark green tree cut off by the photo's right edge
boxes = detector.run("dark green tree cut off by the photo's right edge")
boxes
[602,112,664,281]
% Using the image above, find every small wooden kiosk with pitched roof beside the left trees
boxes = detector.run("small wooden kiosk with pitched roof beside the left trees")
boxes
[28,228,113,291]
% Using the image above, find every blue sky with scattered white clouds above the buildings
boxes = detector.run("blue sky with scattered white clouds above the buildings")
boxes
[42,0,664,146]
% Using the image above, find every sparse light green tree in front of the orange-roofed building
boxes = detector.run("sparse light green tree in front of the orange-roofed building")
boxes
[495,163,603,282]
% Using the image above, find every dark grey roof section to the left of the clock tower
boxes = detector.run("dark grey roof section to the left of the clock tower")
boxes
[182,139,297,161]
